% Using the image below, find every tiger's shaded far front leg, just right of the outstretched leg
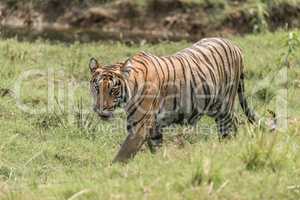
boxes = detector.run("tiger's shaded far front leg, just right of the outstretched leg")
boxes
[147,127,163,153]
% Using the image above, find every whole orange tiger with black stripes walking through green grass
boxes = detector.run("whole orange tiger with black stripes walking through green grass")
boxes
[89,38,257,162]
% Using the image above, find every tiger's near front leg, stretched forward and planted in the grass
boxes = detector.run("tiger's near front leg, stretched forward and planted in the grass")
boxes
[113,120,153,163]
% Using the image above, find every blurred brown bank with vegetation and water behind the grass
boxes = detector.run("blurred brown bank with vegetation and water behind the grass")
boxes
[0,0,300,41]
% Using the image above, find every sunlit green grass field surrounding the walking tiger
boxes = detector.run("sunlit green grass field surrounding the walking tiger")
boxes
[0,31,300,200]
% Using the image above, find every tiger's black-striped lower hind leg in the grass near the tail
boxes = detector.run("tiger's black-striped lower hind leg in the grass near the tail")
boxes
[215,113,237,139]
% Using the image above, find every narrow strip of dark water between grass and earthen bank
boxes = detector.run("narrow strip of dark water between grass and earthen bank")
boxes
[0,26,192,44]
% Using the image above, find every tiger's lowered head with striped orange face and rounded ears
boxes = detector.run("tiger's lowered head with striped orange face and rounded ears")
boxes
[89,58,131,119]
